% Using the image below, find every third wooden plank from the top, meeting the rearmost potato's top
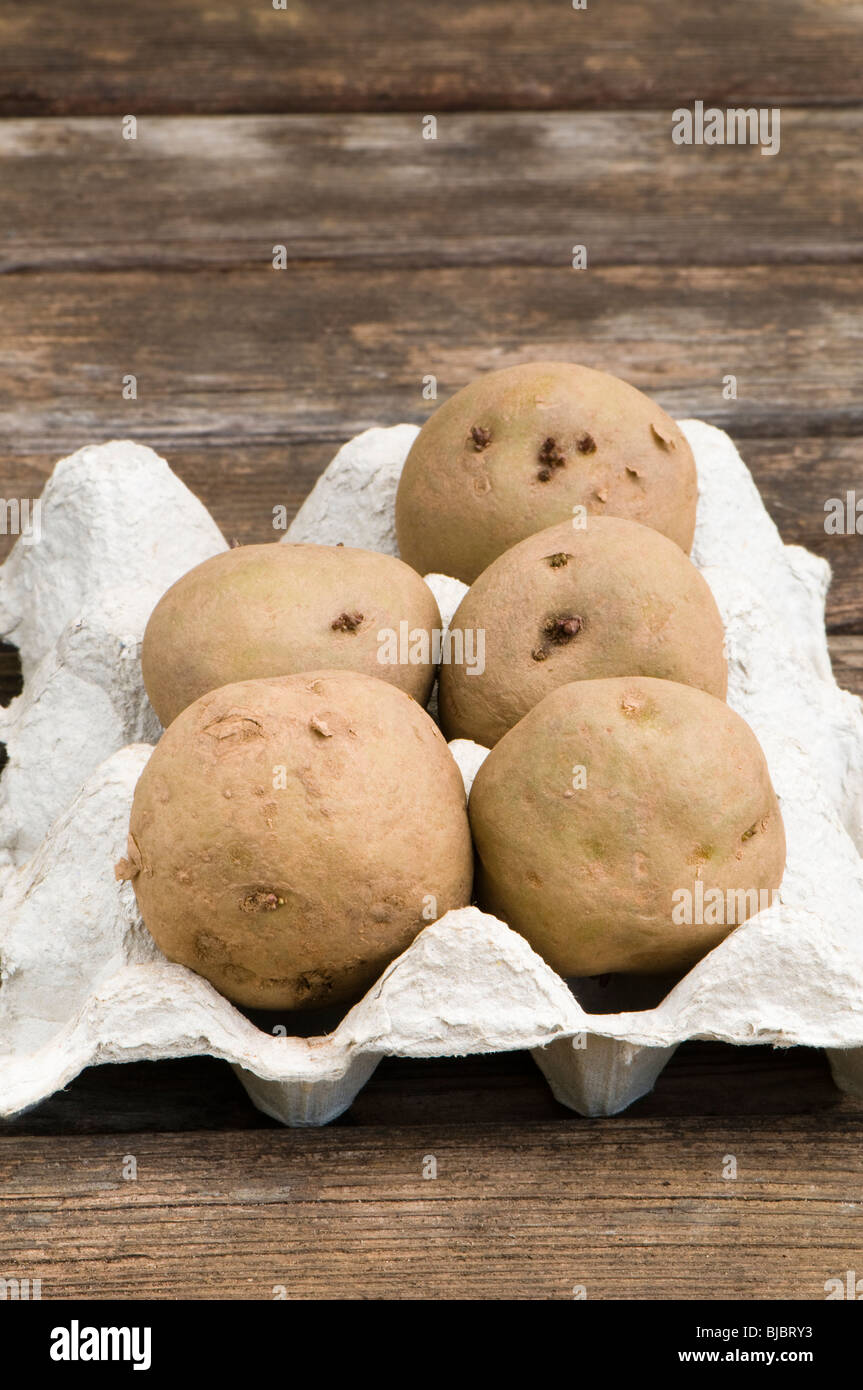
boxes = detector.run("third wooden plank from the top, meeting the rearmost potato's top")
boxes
[0,265,863,450]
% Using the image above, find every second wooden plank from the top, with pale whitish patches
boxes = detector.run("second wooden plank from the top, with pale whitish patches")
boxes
[0,108,863,271]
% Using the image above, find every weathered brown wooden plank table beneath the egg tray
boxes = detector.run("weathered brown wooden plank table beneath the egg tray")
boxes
[0,0,863,1300]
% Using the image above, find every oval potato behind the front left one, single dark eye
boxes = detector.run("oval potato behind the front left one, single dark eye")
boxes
[142,542,441,727]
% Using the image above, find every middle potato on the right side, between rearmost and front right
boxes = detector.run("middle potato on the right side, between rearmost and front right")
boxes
[439,517,728,748]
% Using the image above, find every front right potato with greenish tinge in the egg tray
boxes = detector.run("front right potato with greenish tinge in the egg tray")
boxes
[468,677,785,976]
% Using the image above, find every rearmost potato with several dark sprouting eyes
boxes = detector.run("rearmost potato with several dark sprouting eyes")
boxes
[396,361,698,584]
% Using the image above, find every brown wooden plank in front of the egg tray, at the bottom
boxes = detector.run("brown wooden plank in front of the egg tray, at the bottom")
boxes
[0,1115,863,1300]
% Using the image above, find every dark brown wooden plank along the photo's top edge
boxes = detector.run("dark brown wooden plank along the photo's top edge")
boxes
[0,0,863,115]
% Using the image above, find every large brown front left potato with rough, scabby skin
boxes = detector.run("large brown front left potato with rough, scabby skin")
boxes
[117,671,472,1009]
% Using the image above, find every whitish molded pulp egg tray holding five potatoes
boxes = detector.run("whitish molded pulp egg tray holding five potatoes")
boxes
[0,421,863,1125]
